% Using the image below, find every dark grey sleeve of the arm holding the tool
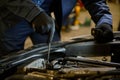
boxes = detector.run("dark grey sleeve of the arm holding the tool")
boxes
[4,0,43,22]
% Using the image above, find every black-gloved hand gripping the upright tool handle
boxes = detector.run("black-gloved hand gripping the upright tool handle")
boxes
[32,12,55,34]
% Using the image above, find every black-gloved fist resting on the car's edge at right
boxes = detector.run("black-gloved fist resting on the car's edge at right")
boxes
[91,24,113,43]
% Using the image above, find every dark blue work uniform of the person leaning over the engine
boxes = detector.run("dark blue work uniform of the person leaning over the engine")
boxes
[0,0,112,51]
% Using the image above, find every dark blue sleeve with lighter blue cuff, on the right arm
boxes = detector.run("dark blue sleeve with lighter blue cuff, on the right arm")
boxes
[82,0,112,25]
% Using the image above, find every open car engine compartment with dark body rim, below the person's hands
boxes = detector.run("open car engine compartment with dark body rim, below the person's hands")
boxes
[0,34,120,80]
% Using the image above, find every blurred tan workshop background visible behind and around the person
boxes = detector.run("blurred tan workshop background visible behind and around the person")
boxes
[25,0,120,48]
